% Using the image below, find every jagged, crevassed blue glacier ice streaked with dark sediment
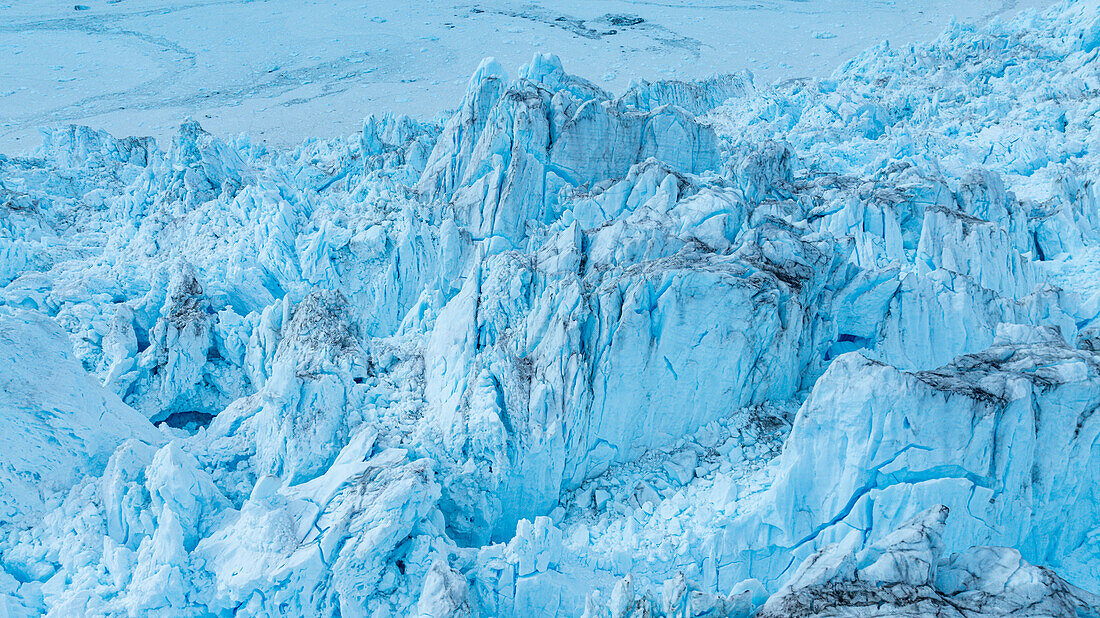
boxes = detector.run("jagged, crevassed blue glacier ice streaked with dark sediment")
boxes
[0,1,1100,617]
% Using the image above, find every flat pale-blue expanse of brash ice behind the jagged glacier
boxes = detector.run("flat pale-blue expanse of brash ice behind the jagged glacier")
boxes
[0,0,1052,153]
